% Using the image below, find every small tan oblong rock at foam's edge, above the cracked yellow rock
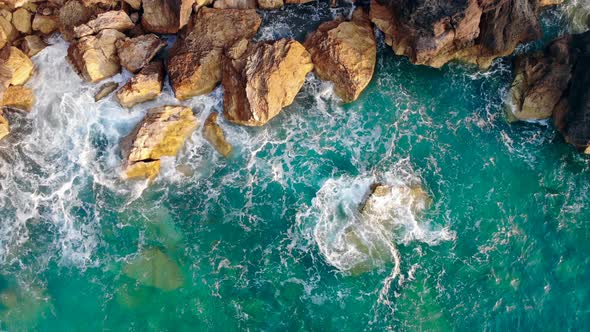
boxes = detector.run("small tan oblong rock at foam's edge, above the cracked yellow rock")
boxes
[117,62,164,108]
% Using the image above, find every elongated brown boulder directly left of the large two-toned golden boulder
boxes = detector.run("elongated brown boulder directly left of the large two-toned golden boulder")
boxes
[168,7,262,100]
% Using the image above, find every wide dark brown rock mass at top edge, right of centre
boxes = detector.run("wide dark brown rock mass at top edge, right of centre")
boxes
[371,0,541,68]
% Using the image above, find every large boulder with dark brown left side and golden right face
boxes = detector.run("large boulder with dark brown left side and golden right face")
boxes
[222,39,313,126]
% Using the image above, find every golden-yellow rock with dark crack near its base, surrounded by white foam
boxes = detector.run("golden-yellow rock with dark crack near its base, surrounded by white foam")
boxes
[121,106,197,180]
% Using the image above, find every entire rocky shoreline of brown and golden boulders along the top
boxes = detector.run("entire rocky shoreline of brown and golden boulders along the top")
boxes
[0,0,590,179]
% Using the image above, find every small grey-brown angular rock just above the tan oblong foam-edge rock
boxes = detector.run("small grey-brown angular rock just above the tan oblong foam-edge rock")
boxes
[117,34,166,73]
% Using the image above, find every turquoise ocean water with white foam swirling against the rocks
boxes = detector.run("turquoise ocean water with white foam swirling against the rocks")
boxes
[0,1,590,331]
